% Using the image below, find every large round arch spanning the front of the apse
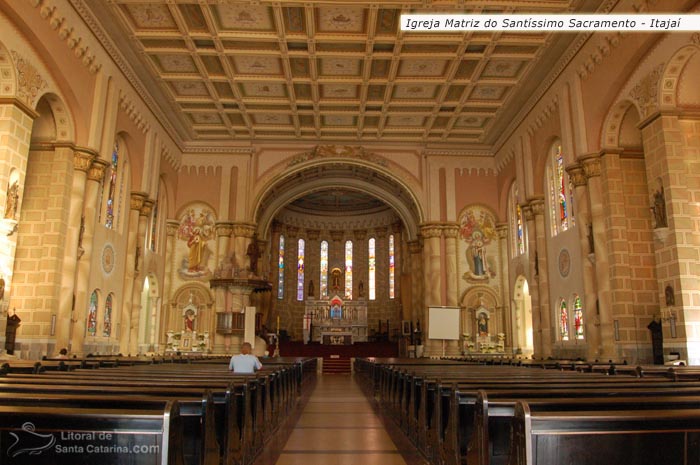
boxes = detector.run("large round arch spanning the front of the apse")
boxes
[253,158,424,240]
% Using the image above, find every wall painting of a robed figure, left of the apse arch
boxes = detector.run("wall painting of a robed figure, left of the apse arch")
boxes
[177,204,216,280]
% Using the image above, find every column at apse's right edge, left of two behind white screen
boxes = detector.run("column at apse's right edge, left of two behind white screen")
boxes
[421,223,442,356]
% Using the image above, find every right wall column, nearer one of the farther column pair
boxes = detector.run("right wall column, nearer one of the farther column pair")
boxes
[530,198,554,358]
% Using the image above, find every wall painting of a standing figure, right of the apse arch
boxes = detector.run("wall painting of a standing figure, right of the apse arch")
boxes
[459,206,498,282]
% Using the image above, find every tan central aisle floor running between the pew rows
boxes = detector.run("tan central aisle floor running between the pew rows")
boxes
[277,375,425,465]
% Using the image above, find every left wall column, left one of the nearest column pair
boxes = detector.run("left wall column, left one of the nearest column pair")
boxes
[56,151,95,351]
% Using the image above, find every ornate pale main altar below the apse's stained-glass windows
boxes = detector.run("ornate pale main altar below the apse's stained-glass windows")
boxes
[304,295,367,345]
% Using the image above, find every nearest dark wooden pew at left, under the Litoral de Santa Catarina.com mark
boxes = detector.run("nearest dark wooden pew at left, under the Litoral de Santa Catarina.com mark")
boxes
[0,401,184,465]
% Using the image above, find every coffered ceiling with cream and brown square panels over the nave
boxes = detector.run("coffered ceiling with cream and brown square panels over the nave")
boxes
[78,0,600,150]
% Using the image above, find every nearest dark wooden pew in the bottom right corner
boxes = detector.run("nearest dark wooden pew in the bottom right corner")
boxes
[508,401,700,465]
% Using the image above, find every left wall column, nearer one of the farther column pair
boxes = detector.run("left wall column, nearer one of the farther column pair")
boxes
[119,192,148,355]
